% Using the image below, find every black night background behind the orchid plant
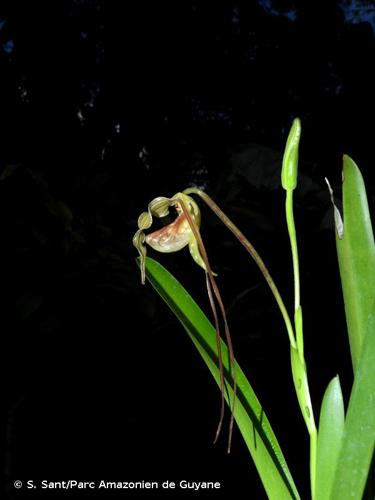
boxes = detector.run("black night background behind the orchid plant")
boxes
[0,0,375,499]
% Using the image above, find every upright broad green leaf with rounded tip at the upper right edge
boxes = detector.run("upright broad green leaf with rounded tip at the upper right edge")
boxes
[336,156,375,371]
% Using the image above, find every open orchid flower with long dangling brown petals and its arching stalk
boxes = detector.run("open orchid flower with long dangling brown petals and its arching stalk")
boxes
[133,187,302,453]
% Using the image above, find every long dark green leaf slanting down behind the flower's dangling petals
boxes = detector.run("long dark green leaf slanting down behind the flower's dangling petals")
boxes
[140,258,300,500]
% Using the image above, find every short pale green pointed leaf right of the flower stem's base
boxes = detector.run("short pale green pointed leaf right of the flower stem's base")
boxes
[315,376,345,500]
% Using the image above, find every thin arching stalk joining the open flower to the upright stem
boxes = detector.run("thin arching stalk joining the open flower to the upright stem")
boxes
[184,188,296,348]
